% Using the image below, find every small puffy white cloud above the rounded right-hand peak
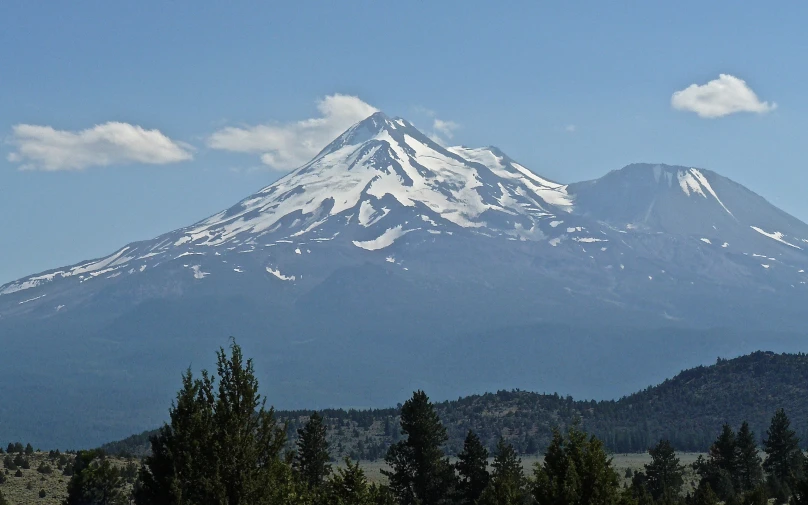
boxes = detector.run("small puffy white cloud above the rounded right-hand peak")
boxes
[671,74,777,118]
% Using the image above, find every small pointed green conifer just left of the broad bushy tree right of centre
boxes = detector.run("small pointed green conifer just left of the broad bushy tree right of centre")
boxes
[477,438,530,505]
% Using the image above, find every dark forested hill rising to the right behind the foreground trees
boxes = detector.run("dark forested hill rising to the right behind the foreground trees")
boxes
[105,352,808,459]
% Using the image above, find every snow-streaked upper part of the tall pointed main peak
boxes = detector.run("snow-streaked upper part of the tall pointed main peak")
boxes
[179,112,571,245]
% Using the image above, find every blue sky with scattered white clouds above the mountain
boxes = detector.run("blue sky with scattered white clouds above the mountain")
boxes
[0,1,808,284]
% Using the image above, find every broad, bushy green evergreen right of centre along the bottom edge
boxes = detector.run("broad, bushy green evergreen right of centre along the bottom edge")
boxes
[533,424,622,505]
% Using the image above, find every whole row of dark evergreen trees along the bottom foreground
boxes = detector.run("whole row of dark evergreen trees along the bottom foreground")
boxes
[20,342,808,505]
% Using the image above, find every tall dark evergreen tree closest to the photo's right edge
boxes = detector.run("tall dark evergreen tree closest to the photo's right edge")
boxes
[763,409,804,501]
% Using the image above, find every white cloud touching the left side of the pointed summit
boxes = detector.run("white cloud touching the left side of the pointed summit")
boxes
[207,94,377,170]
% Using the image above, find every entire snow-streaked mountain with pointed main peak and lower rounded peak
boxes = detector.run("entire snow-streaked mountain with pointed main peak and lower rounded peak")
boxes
[0,113,808,445]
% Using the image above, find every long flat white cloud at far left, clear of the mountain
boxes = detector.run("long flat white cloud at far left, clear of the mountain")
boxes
[7,122,193,172]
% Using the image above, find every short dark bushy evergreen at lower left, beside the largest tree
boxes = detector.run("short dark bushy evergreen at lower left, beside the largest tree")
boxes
[64,451,129,505]
